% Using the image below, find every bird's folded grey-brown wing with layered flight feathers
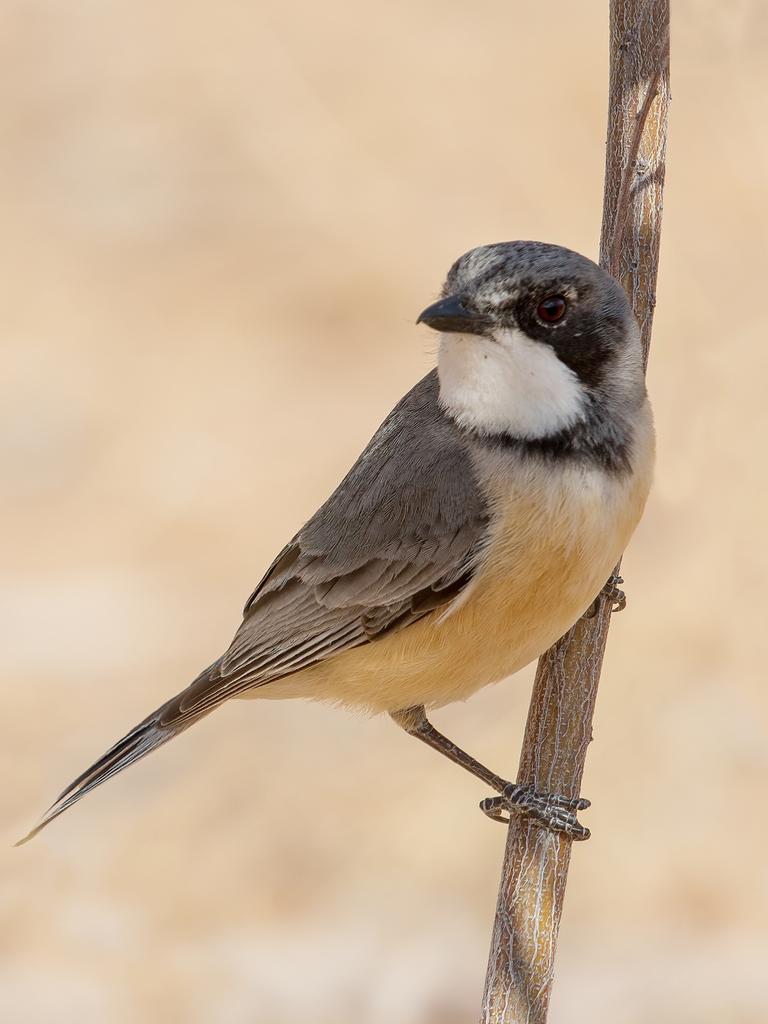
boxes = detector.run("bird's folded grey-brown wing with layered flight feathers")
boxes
[183,372,488,716]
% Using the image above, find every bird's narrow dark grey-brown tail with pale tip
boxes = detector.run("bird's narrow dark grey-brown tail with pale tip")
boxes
[15,662,225,846]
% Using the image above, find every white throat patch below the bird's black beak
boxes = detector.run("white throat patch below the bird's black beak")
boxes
[437,328,585,439]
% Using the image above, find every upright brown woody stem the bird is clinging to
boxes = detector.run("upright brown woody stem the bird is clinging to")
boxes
[481,0,670,1024]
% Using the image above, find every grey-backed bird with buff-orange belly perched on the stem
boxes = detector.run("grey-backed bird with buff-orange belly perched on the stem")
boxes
[20,241,654,843]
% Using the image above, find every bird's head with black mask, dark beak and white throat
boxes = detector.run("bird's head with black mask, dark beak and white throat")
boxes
[419,242,644,438]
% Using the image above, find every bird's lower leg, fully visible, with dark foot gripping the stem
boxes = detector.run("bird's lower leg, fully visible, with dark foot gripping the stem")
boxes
[390,705,590,840]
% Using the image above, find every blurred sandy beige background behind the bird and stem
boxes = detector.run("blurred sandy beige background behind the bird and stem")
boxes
[0,0,768,1024]
